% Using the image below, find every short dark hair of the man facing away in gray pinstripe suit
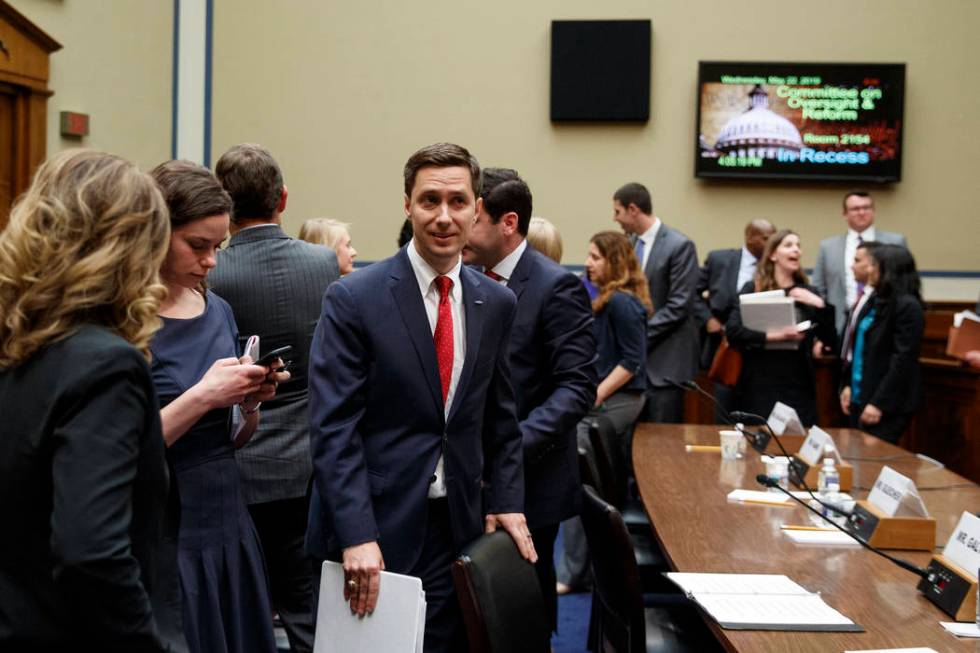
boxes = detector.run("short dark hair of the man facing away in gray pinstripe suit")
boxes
[214,143,282,224]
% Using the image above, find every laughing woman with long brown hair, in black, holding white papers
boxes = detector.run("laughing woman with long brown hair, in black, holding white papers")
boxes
[725,229,836,427]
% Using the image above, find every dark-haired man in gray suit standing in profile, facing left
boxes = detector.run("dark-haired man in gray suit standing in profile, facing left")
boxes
[613,183,699,423]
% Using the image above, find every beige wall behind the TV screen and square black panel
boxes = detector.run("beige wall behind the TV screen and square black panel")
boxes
[213,0,980,286]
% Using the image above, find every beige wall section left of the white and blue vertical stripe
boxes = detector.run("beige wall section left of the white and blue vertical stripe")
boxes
[12,0,173,168]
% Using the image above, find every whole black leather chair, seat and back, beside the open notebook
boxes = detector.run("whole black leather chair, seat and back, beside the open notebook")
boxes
[582,486,722,653]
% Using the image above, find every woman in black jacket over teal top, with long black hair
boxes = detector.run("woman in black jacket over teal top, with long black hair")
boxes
[840,244,925,443]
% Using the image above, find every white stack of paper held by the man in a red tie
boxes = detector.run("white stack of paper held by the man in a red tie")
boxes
[313,561,425,653]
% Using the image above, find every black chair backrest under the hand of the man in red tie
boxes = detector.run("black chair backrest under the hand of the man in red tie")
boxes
[452,530,551,653]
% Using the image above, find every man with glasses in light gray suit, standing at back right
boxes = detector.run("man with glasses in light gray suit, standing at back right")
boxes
[811,190,908,340]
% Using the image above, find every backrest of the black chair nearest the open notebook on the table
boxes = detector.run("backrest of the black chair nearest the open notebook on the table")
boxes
[582,486,646,653]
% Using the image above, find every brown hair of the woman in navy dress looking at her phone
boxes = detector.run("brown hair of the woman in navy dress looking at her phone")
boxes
[150,161,232,227]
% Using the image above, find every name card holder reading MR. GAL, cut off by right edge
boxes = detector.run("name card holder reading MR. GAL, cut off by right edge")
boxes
[918,512,980,622]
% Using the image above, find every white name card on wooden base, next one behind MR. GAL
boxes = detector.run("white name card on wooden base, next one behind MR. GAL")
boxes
[846,466,936,551]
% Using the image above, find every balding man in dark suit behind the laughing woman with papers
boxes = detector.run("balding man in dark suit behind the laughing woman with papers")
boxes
[695,218,776,422]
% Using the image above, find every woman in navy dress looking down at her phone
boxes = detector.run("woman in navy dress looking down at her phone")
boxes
[150,161,289,653]
